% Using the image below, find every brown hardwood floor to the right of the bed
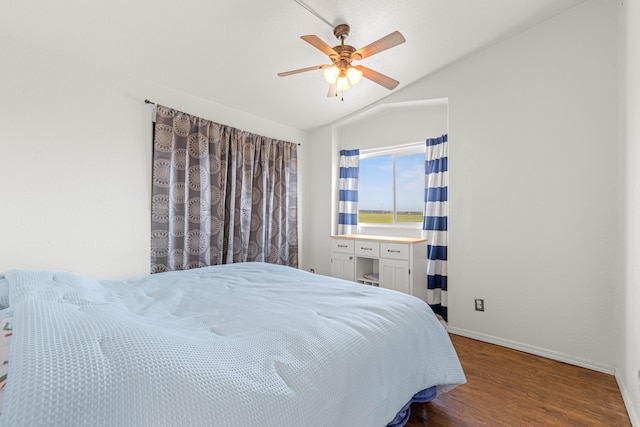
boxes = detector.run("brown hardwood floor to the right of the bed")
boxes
[406,335,631,427]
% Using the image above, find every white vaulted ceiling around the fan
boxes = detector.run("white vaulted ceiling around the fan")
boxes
[0,0,585,129]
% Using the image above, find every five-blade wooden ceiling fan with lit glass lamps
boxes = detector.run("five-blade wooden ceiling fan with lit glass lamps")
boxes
[278,24,406,96]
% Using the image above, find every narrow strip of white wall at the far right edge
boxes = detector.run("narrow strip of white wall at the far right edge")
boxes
[618,1,640,426]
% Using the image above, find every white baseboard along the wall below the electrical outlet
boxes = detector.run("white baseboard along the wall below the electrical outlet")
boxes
[447,326,616,374]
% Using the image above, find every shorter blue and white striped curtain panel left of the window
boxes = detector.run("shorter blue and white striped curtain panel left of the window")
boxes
[338,150,360,234]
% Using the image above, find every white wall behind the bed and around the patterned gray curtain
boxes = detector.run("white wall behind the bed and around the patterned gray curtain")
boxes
[0,37,305,277]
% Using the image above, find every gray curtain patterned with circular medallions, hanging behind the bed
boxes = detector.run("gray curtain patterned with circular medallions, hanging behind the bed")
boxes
[151,105,298,273]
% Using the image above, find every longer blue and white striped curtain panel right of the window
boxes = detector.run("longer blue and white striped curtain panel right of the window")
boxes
[422,135,449,321]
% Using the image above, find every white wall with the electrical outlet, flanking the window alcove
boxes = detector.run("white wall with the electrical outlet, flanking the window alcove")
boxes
[305,0,621,372]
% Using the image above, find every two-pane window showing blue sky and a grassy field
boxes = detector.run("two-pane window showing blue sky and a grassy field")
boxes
[358,143,425,226]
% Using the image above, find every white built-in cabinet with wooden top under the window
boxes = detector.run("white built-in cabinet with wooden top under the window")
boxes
[331,234,427,300]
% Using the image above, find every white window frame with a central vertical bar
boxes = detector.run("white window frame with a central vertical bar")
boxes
[358,141,427,230]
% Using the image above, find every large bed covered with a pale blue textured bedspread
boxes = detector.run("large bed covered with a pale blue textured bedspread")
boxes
[0,262,465,427]
